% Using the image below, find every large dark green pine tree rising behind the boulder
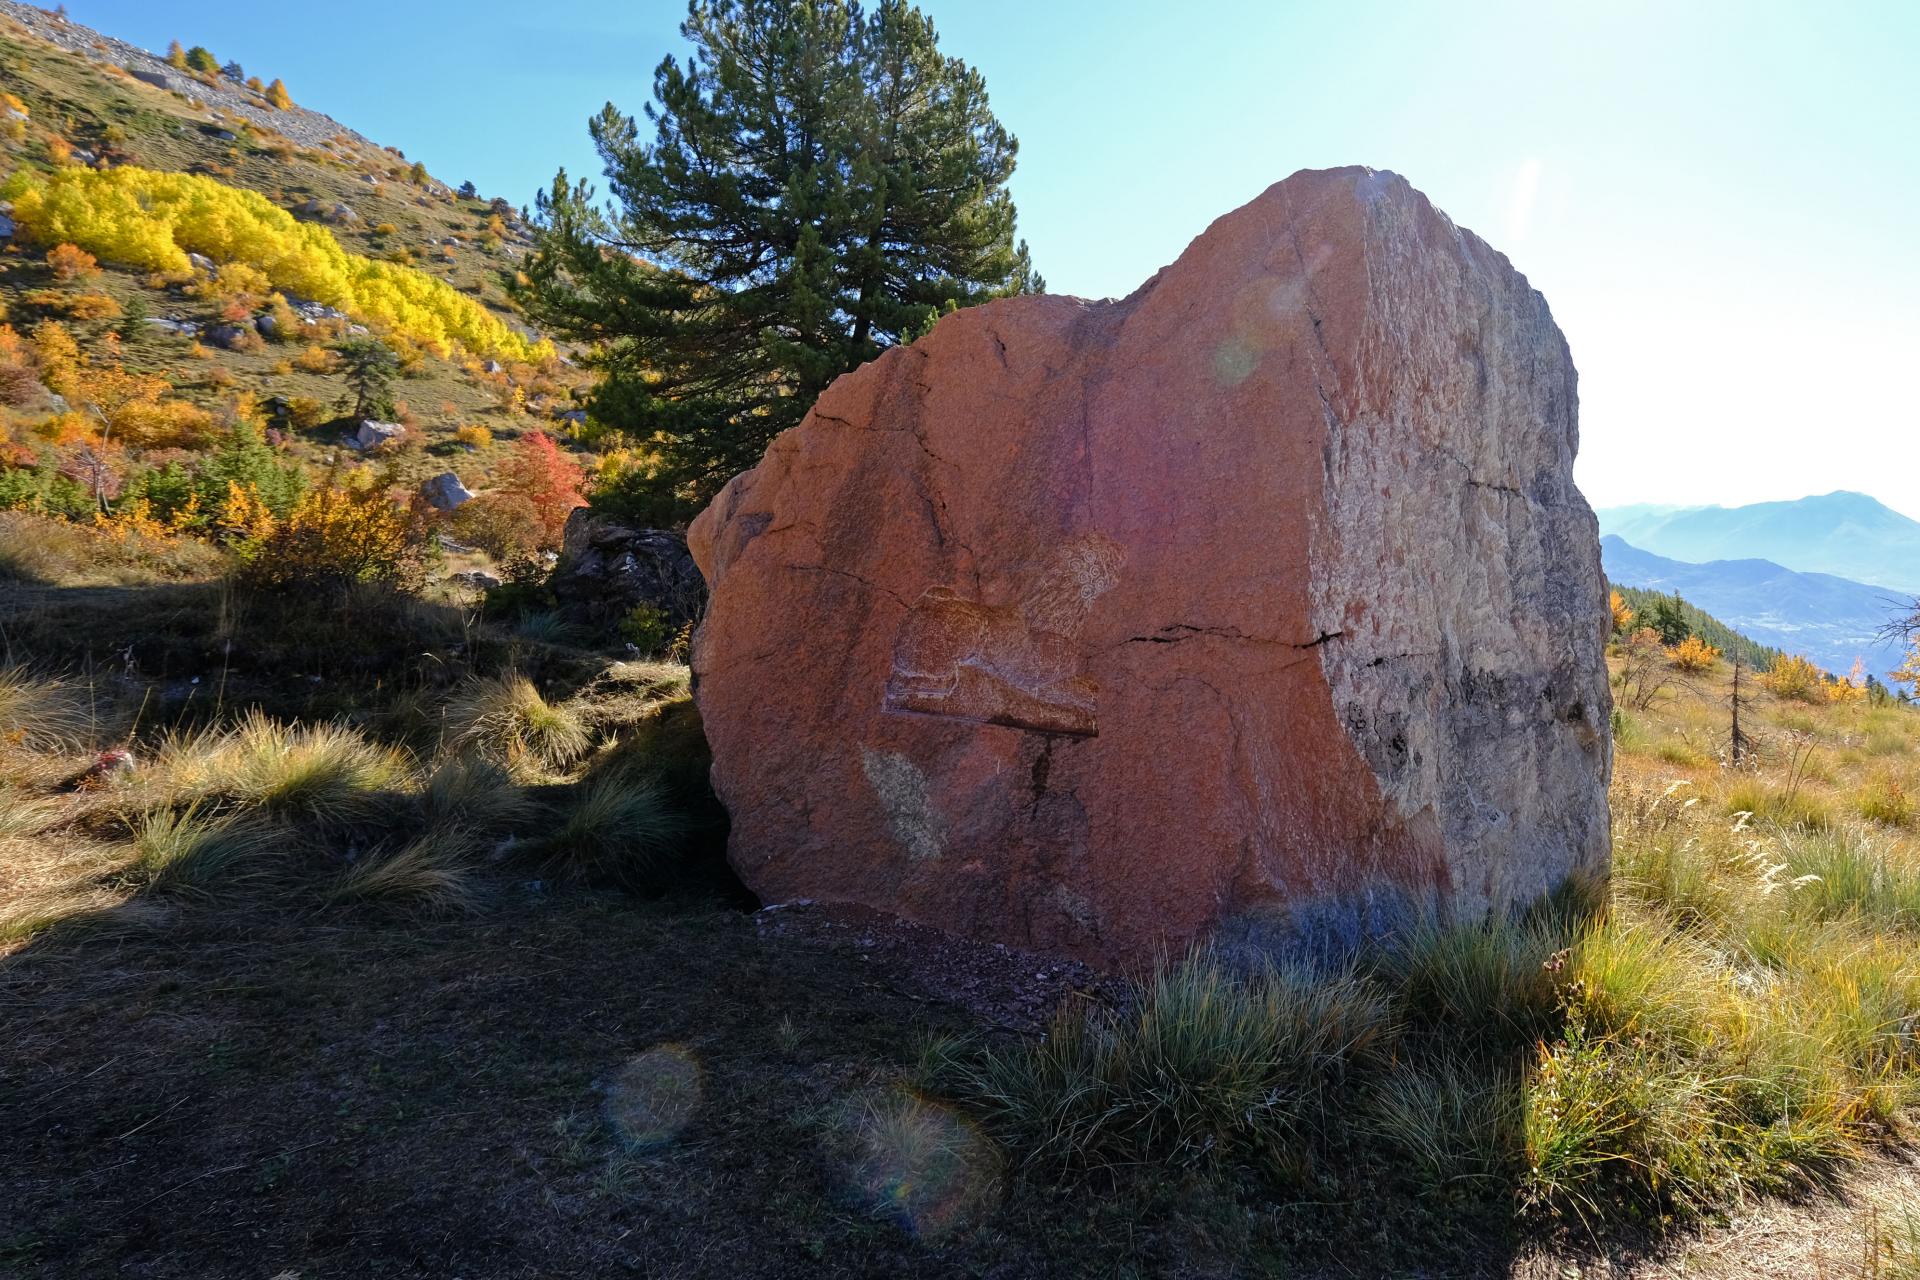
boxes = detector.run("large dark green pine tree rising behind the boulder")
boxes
[520,0,1043,512]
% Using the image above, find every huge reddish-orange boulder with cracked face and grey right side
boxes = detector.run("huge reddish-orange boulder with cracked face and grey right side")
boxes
[689,169,1611,965]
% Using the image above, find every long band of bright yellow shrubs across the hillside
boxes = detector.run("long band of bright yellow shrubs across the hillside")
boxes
[0,165,551,361]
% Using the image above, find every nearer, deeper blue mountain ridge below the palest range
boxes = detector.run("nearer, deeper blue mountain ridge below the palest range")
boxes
[1599,537,1903,677]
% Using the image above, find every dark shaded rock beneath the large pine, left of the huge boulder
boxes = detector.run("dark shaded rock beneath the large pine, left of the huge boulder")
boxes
[551,507,707,628]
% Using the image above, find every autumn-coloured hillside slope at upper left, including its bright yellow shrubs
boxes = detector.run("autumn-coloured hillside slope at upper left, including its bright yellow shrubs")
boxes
[0,6,599,564]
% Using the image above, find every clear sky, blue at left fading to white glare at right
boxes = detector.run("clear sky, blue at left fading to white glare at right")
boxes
[52,0,1920,516]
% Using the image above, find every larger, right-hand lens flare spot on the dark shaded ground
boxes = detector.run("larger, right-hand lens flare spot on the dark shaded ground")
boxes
[841,1090,1000,1238]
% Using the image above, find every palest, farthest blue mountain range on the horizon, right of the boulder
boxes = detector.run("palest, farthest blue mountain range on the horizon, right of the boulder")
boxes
[1596,489,1920,595]
